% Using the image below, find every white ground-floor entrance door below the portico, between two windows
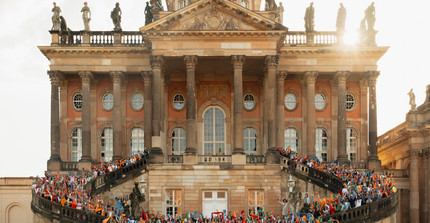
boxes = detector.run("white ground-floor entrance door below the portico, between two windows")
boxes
[202,191,228,218]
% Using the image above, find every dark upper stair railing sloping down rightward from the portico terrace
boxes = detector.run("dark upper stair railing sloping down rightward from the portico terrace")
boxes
[282,158,343,193]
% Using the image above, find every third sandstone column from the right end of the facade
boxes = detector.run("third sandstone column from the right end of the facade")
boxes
[305,71,318,157]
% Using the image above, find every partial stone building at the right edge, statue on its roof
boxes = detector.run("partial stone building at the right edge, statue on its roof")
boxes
[378,85,430,222]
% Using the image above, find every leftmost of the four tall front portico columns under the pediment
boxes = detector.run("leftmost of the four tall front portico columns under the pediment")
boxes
[149,55,164,163]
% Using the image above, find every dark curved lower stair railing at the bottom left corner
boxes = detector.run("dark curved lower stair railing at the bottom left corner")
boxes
[31,191,106,223]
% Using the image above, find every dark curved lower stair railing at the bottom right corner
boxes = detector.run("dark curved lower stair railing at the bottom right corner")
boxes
[322,192,399,222]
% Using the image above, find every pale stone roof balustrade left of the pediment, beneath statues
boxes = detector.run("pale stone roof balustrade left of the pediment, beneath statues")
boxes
[50,31,146,46]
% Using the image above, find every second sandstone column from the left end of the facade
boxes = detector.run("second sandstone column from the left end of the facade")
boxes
[79,71,94,169]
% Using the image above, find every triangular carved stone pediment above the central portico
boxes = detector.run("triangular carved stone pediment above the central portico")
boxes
[141,0,287,32]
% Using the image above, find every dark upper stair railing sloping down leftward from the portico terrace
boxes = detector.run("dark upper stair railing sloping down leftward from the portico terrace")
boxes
[84,158,146,194]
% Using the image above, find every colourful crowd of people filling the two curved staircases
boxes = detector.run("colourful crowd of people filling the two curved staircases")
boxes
[33,148,396,223]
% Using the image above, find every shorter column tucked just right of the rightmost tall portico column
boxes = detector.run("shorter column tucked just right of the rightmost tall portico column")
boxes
[276,71,287,149]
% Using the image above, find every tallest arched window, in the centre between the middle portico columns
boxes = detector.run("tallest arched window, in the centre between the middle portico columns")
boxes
[203,107,225,155]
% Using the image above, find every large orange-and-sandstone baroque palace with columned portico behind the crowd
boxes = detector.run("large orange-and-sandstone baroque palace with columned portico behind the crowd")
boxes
[33,0,400,220]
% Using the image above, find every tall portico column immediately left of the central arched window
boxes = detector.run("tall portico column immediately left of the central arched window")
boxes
[184,55,198,155]
